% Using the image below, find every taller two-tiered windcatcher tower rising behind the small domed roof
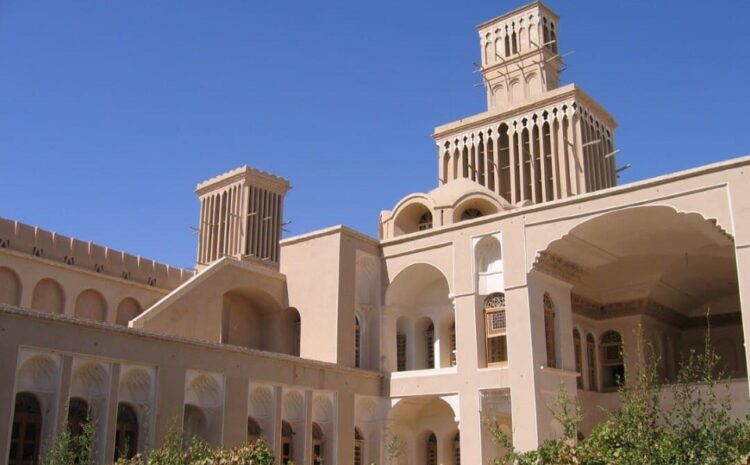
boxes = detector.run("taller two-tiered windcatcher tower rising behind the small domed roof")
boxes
[433,2,617,205]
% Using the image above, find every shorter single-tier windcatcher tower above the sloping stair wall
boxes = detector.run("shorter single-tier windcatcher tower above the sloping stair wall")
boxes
[195,166,290,269]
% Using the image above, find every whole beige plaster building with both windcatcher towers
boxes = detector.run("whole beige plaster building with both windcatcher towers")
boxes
[0,3,750,465]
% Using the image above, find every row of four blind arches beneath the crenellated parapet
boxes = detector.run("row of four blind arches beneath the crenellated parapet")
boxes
[0,267,143,326]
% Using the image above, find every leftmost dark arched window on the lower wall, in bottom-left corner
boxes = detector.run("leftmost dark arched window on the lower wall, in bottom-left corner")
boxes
[8,392,42,465]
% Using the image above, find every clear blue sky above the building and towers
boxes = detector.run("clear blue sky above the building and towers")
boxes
[0,0,750,267]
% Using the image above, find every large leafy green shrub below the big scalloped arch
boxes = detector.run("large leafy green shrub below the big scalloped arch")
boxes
[484,326,750,465]
